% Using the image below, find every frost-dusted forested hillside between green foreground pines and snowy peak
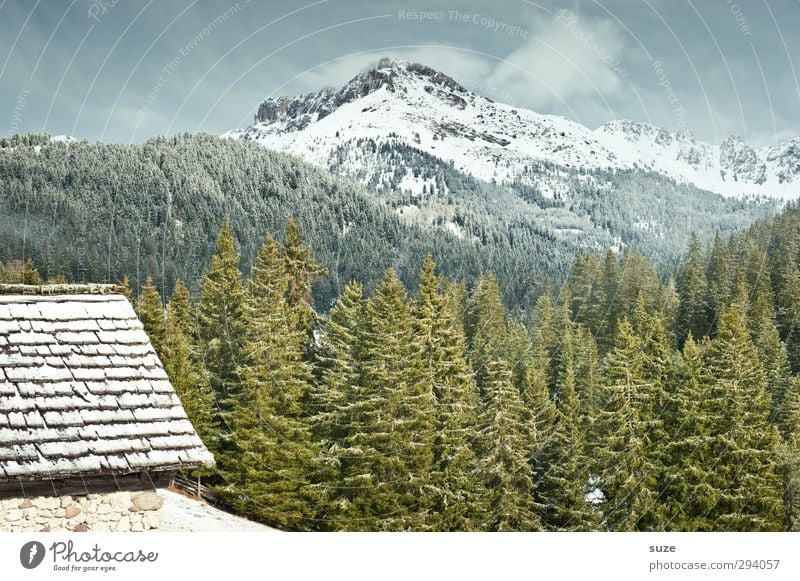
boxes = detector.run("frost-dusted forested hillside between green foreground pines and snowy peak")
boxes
[0,135,775,311]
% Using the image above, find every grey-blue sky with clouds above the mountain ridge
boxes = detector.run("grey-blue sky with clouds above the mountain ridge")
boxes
[0,0,800,146]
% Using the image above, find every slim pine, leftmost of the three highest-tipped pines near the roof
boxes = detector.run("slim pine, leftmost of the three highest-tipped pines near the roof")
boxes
[197,222,246,411]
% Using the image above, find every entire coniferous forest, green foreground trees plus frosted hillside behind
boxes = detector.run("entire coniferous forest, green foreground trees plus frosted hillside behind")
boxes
[0,136,800,531]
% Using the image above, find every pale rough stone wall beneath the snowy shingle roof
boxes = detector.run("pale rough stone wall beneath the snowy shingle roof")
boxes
[0,491,164,532]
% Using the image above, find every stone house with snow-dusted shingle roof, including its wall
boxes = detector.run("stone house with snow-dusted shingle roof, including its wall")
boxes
[0,285,213,531]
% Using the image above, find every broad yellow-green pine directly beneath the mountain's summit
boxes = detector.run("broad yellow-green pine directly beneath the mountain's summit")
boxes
[341,270,435,530]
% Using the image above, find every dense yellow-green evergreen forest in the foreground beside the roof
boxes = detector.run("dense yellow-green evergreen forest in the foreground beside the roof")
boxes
[18,207,788,531]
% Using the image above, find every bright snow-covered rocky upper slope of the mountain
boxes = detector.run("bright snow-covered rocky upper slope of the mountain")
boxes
[225,59,800,198]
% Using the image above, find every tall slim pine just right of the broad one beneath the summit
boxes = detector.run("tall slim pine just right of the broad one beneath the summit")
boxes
[414,256,480,531]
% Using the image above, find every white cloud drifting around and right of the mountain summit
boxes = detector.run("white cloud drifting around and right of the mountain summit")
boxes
[276,10,629,117]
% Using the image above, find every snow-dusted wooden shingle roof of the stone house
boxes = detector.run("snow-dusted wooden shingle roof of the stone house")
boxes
[0,285,213,482]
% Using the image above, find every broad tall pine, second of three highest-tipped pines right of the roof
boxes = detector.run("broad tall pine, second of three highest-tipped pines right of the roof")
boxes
[222,237,322,529]
